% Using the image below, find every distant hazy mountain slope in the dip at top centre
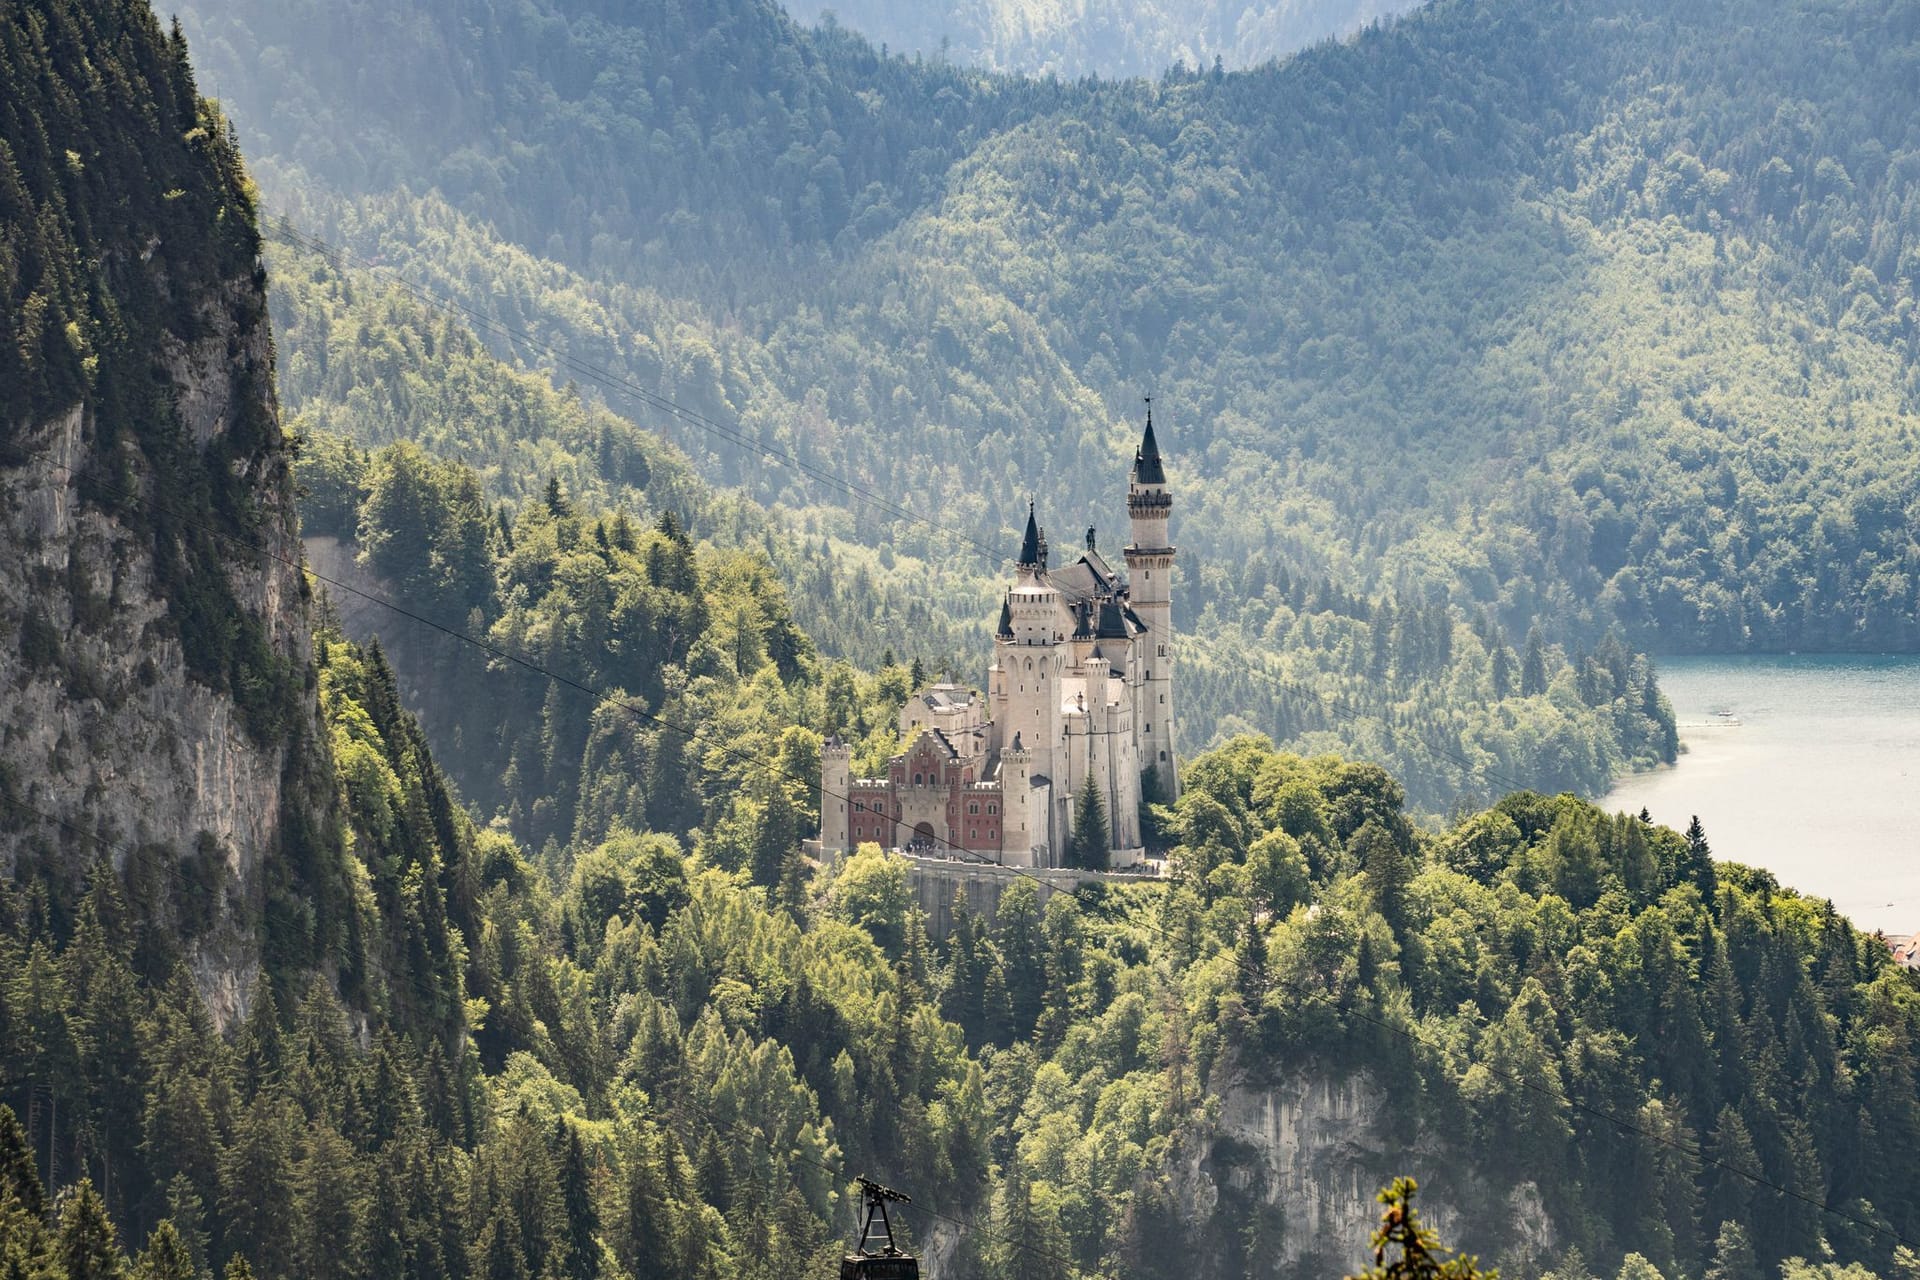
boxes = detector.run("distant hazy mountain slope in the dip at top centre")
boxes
[787,0,1419,77]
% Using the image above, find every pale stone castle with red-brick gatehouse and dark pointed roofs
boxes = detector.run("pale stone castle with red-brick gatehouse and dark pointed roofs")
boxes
[820,403,1179,867]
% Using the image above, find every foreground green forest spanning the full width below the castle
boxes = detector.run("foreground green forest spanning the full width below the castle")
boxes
[0,667,1920,1280]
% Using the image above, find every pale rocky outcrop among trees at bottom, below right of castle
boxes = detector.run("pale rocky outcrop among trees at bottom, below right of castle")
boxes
[1173,1065,1557,1276]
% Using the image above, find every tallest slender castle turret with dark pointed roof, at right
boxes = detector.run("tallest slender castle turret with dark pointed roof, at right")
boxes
[1125,399,1179,802]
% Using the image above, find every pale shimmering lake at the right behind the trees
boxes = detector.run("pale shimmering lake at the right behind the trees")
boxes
[1601,656,1920,935]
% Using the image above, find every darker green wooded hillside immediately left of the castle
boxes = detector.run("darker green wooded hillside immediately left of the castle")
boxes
[311,445,933,852]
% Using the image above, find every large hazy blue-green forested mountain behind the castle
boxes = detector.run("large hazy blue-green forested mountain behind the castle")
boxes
[188,0,1920,667]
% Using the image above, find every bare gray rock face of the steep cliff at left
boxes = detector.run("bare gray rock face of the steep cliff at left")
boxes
[0,280,326,1021]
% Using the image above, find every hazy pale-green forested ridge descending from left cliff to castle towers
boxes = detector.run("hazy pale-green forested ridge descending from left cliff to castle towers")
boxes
[271,211,987,687]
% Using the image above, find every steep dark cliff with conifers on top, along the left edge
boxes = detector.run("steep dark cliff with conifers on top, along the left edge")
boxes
[0,0,332,1019]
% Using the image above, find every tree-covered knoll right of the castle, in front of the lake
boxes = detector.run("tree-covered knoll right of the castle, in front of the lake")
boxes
[1160,739,1920,1274]
